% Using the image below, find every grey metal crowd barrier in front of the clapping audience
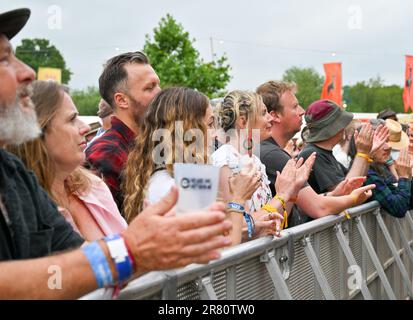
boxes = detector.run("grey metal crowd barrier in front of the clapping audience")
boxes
[80,201,413,299]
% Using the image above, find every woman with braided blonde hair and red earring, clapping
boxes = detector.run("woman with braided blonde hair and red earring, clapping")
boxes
[212,91,315,236]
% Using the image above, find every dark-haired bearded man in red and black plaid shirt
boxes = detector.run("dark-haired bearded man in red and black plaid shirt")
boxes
[86,51,160,212]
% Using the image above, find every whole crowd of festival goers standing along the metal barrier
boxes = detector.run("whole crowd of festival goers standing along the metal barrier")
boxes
[0,9,413,298]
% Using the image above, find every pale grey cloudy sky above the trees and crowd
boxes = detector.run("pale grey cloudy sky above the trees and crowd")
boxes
[0,0,413,89]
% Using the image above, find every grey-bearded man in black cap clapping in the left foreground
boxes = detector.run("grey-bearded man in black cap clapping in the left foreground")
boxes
[0,9,231,299]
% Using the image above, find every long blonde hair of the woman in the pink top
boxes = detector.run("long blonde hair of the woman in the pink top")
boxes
[6,81,90,205]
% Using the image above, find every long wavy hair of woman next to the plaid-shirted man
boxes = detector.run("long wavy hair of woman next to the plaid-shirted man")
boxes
[123,87,209,222]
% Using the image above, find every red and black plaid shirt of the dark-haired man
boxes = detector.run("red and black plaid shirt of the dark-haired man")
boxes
[86,117,135,212]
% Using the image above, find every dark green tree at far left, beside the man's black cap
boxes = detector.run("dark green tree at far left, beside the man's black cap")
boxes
[16,39,73,84]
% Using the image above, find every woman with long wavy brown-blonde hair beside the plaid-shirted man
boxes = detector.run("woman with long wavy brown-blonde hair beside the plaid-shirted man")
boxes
[124,88,259,244]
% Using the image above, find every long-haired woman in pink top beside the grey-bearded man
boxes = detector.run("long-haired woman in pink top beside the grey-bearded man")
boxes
[7,81,127,241]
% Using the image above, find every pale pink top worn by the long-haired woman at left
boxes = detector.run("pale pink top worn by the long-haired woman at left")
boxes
[59,174,128,236]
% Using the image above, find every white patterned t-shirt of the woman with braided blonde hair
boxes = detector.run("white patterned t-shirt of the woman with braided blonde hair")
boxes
[211,144,272,213]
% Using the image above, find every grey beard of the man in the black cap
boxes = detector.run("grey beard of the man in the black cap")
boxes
[0,87,41,145]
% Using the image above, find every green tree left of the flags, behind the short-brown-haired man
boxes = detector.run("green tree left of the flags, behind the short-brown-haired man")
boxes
[283,67,324,109]
